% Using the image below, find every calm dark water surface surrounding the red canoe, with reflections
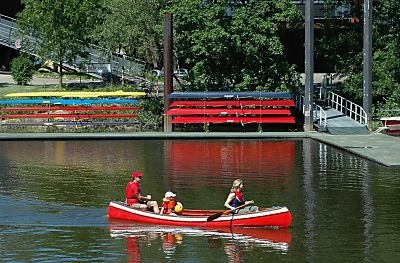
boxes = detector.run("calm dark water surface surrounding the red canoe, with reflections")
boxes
[0,140,400,262]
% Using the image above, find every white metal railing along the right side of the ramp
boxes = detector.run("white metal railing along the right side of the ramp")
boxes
[327,92,368,126]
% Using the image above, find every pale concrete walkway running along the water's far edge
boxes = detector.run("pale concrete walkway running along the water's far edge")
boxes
[0,132,400,167]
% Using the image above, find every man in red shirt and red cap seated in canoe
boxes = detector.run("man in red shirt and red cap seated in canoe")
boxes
[125,172,160,213]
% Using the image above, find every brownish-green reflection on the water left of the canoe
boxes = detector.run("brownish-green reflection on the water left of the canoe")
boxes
[0,140,153,206]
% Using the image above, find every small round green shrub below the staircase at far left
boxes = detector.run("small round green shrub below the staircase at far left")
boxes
[11,55,34,85]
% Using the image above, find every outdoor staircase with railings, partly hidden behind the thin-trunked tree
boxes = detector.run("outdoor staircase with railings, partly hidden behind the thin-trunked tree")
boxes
[0,14,145,81]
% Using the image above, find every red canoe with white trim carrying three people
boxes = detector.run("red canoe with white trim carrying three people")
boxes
[108,202,292,228]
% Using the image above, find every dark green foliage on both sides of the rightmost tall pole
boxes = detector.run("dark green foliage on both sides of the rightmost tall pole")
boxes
[316,0,400,112]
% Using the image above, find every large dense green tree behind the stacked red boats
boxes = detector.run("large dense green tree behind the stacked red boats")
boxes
[168,0,303,91]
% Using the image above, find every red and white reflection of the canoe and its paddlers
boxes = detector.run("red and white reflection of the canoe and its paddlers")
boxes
[109,220,292,262]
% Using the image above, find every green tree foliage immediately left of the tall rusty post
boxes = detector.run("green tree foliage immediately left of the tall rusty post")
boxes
[96,0,165,68]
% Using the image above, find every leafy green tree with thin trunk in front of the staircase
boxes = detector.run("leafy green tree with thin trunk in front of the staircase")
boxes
[17,0,100,86]
